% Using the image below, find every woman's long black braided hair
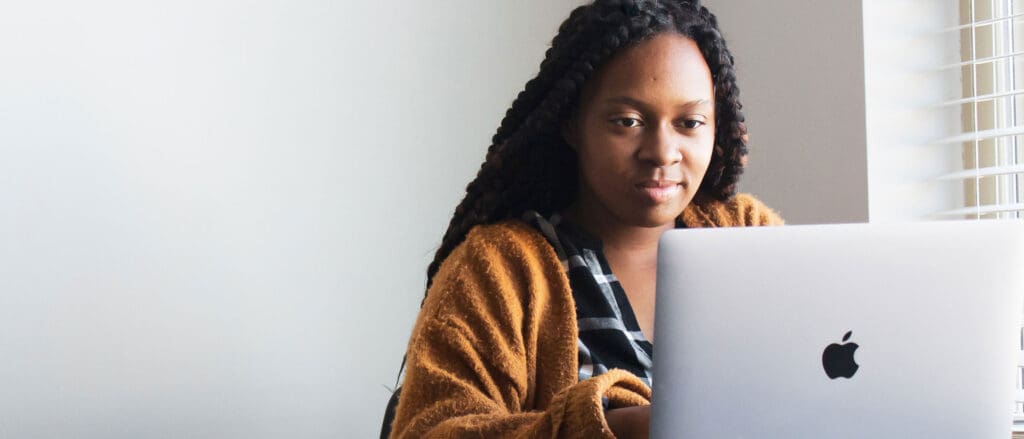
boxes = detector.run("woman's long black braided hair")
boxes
[427,0,748,290]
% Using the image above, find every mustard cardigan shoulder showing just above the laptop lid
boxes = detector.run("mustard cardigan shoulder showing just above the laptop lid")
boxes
[683,193,784,227]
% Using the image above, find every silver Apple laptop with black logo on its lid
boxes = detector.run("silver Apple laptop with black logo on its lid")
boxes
[651,221,1024,439]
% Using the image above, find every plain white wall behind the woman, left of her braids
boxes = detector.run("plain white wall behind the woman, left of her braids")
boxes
[0,0,578,438]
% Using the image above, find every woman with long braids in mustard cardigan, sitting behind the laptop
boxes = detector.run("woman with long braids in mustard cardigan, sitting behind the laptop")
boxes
[391,0,781,438]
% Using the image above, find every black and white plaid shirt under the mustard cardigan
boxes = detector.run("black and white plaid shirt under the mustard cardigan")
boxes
[523,211,680,386]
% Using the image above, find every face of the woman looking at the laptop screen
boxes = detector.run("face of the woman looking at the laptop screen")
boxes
[564,34,715,227]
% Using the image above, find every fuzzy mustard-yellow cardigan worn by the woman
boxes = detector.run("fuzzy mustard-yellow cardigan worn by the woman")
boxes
[391,194,782,438]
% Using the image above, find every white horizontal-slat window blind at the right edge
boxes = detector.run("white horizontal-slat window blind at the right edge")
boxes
[937,0,1024,432]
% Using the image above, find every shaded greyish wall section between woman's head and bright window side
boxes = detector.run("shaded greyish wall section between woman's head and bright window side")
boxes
[703,0,868,224]
